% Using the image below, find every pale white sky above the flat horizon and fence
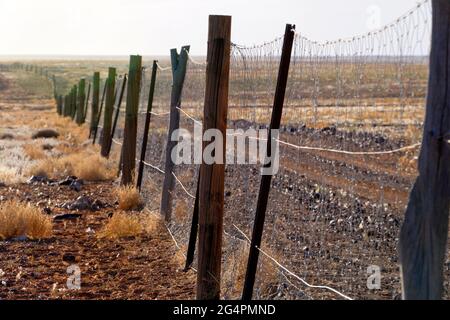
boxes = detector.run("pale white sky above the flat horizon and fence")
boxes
[0,0,426,55]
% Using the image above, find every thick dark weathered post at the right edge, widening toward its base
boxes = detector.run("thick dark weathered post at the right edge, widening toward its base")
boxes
[399,0,450,300]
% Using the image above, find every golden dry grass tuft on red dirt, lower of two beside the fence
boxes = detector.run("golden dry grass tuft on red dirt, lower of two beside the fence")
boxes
[99,212,144,240]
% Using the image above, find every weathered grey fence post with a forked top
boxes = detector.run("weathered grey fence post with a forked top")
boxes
[160,46,190,221]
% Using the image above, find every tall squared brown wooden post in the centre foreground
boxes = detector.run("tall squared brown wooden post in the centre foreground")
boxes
[197,16,231,300]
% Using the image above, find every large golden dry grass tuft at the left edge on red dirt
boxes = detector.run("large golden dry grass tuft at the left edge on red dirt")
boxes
[0,201,52,240]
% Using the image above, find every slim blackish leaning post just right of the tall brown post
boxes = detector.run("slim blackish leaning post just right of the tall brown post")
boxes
[242,24,295,300]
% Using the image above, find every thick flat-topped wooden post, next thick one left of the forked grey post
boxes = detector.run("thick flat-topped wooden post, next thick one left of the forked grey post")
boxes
[121,56,142,185]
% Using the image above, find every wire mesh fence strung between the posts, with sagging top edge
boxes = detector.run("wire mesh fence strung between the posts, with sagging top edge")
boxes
[29,1,450,299]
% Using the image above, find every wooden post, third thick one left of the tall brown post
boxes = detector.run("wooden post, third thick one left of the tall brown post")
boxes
[101,68,116,157]
